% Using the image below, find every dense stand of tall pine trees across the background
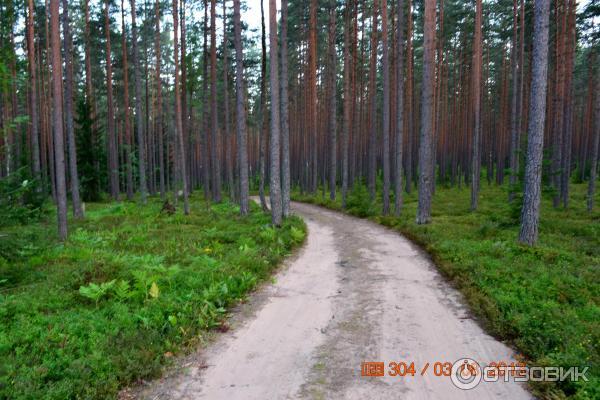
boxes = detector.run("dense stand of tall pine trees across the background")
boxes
[0,0,600,244]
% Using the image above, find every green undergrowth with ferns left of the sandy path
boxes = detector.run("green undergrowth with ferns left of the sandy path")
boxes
[0,197,306,400]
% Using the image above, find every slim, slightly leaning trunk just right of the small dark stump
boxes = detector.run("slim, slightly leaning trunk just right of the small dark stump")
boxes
[173,0,190,215]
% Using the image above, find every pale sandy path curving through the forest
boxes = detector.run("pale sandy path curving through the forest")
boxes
[134,203,531,400]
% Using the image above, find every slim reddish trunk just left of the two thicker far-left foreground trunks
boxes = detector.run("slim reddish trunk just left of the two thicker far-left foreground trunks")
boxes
[27,0,41,180]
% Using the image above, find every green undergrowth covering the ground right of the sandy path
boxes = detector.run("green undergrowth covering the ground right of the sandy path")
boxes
[293,184,600,399]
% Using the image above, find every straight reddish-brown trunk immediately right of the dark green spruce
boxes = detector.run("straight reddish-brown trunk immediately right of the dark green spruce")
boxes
[104,0,119,200]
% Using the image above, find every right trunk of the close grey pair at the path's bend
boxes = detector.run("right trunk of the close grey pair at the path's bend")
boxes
[280,0,291,218]
